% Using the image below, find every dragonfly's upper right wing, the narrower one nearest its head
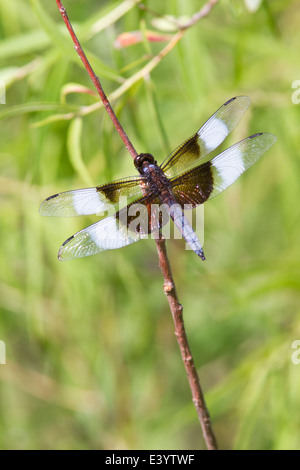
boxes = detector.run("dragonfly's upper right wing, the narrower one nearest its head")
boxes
[161,96,250,178]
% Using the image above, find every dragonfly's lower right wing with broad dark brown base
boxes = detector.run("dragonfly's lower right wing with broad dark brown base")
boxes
[171,133,276,208]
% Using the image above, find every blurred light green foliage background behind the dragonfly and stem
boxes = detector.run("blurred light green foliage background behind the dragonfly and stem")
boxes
[0,0,300,449]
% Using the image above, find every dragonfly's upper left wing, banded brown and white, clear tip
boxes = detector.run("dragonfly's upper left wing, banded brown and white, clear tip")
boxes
[40,176,143,217]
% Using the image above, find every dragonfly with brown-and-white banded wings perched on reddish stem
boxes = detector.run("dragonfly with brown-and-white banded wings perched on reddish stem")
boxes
[40,96,276,260]
